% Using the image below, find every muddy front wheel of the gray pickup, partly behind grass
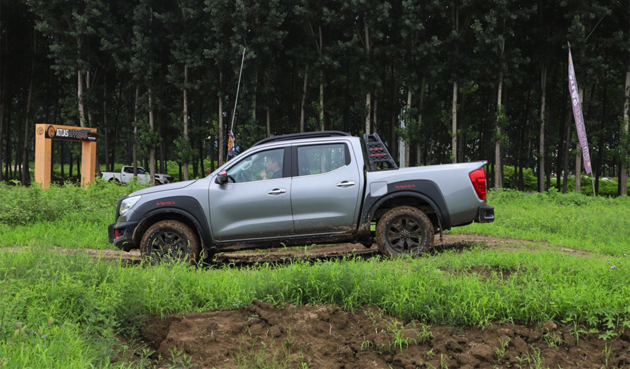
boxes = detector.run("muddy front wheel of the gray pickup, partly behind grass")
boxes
[140,220,201,265]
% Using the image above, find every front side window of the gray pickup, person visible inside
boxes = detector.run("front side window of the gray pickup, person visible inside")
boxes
[227,149,284,183]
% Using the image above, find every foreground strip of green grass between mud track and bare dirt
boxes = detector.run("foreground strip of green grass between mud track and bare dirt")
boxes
[0,248,630,368]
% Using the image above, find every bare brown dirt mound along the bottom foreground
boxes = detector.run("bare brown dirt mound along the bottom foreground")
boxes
[144,302,630,369]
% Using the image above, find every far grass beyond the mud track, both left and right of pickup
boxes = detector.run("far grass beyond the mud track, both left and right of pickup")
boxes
[0,181,630,255]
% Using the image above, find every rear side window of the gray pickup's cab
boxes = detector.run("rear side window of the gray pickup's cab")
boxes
[297,143,350,176]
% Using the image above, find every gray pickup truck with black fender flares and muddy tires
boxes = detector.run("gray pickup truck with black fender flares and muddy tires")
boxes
[108,131,494,262]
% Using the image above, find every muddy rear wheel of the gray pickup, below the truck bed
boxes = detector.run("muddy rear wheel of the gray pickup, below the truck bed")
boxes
[376,206,435,256]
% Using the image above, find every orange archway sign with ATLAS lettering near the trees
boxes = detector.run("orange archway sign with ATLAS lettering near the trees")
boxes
[35,123,96,189]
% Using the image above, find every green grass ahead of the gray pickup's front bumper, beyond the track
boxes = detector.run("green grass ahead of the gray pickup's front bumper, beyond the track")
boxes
[0,179,143,248]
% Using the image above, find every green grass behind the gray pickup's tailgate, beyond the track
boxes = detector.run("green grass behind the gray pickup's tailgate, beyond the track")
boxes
[452,189,630,255]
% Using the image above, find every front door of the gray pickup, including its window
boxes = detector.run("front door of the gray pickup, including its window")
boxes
[209,148,294,241]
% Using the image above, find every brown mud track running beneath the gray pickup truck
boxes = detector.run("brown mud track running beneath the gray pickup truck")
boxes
[85,234,556,266]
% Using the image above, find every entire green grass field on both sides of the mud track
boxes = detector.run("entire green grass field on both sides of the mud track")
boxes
[0,182,630,368]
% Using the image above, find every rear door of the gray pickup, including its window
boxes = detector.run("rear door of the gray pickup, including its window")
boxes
[291,141,361,234]
